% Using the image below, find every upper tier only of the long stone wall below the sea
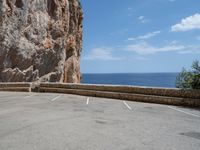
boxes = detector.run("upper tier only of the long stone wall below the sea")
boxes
[40,83,200,99]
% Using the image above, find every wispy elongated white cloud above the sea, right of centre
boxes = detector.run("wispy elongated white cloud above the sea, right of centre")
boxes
[125,42,186,55]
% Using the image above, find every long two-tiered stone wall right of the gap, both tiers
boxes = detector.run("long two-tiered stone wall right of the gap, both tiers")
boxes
[39,83,200,107]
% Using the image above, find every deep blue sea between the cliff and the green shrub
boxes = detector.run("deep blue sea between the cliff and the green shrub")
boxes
[81,73,178,88]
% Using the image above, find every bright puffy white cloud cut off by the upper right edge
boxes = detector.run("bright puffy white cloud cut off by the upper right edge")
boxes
[171,13,200,32]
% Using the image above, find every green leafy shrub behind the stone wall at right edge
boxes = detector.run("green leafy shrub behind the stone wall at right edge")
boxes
[176,61,200,89]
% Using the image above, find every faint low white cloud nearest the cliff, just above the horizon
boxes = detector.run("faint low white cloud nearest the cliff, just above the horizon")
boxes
[84,48,124,60]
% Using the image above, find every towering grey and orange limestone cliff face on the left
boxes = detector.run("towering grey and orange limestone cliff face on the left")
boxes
[0,0,83,83]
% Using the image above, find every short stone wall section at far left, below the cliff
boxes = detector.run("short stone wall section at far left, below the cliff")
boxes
[0,83,32,92]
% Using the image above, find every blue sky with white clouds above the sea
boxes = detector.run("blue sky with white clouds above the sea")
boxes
[81,0,200,73]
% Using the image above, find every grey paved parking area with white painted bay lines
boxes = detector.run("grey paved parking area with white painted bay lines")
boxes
[0,92,200,150]
